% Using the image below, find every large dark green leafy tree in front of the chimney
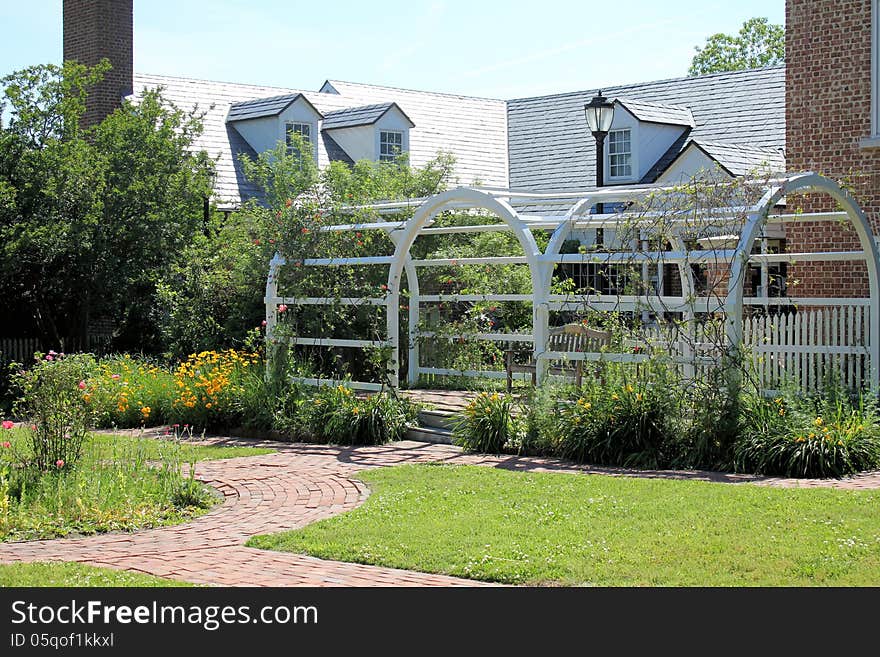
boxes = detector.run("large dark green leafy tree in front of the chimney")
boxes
[0,62,212,350]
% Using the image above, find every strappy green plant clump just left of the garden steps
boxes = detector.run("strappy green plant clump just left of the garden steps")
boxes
[294,384,417,445]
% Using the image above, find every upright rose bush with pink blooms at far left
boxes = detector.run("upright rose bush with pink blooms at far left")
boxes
[13,351,95,471]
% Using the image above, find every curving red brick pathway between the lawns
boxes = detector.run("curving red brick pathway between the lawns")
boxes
[0,438,880,586]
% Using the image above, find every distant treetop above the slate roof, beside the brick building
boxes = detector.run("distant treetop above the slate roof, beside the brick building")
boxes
[688,18,785,75]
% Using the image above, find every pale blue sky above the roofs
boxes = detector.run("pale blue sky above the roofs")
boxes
[0,0,785,99]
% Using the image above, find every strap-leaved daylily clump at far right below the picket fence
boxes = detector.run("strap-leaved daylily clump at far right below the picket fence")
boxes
[734,391,880,477]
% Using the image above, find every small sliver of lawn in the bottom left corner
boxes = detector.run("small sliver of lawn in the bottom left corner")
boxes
[0,562,193,587]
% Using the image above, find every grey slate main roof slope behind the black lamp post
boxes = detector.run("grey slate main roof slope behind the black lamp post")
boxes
[507,66,785,191]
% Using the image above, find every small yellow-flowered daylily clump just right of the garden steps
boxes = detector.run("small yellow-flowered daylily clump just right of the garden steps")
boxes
[452,392,525,454]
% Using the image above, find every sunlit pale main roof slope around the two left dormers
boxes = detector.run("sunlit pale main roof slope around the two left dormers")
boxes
[134,74,507,208]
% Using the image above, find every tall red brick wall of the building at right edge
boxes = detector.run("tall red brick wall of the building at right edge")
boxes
[785,0,880,296]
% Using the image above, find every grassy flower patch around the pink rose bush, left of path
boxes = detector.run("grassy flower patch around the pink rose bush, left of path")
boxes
[0,429,272,541]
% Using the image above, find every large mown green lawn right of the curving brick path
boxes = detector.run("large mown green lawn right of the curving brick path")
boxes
[248,465,880,586]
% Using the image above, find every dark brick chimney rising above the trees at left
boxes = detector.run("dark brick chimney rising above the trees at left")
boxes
[64,0,134,125]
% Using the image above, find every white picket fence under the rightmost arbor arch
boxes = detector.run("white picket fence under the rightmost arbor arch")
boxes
[743,305,870,391]
